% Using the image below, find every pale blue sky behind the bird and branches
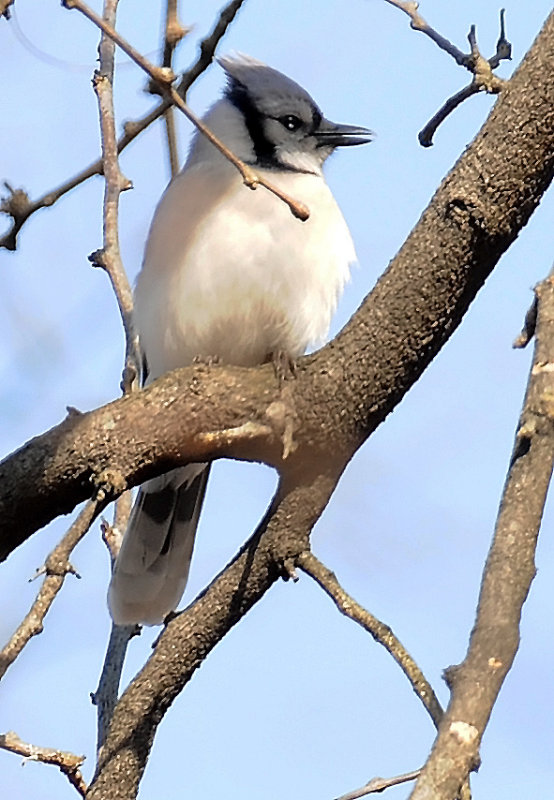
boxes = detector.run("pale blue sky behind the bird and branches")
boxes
[0,0,554,800]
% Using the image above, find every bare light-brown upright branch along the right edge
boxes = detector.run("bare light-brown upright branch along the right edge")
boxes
[411,260,554,800]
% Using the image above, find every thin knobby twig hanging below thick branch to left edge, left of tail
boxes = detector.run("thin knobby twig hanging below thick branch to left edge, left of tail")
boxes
[0,501,99,678]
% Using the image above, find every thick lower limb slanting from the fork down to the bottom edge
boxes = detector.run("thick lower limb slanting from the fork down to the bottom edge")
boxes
[87,476,336,800]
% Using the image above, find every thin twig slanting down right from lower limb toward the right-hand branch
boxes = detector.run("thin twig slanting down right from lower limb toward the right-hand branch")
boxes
[297,551,443,728]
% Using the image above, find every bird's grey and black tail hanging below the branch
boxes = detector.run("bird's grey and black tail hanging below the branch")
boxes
[108,464,210,625]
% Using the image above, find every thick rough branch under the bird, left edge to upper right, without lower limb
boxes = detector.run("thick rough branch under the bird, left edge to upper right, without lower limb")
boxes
[0,15,554,557]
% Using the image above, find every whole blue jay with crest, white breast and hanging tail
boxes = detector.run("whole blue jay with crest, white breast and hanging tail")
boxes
[108,54,373,625]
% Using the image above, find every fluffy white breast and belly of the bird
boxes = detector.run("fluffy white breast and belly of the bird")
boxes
[135,163,355,377]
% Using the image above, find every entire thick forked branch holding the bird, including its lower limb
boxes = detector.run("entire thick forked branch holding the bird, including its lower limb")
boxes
[0,7,554,800]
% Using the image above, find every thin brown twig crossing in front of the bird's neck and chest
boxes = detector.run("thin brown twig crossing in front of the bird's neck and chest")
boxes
[64,0,310,221]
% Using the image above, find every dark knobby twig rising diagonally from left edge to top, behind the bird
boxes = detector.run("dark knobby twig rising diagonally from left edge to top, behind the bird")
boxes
[0,0,244,250]
